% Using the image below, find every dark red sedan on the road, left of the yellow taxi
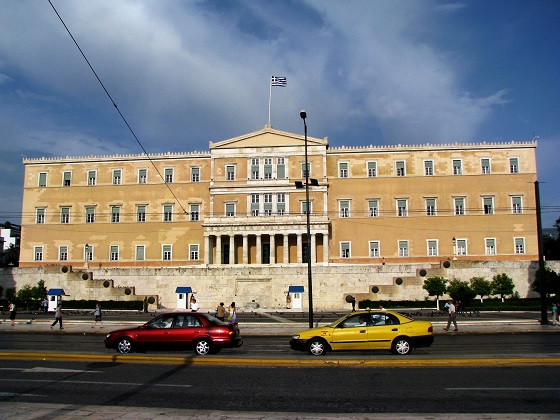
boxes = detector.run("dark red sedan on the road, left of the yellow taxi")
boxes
[105,312,243,355]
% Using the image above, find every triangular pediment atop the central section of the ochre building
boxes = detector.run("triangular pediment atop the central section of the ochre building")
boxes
[210,125,329,150]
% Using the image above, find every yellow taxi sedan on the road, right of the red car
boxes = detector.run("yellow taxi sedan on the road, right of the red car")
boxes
[290,309,434,356]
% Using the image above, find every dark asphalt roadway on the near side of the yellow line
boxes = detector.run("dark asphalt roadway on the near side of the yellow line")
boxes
[0,360,560,418]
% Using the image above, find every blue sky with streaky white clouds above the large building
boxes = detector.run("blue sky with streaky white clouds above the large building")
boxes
[0,0,560,228]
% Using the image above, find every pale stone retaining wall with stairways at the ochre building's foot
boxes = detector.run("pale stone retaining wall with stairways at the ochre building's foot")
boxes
[0,261,560,310]
